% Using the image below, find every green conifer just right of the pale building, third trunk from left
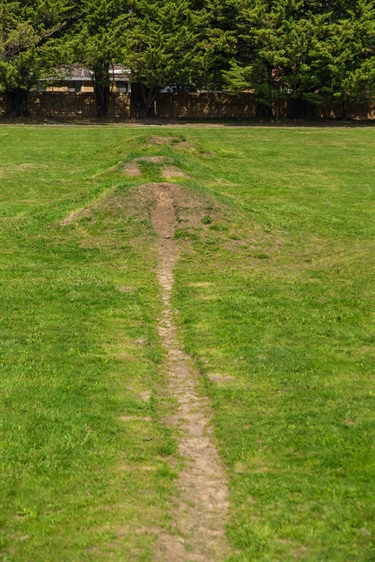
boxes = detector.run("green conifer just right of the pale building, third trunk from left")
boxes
[117,0,201,118]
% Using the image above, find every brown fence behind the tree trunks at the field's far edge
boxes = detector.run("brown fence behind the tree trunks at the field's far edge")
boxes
[0,92,375,121]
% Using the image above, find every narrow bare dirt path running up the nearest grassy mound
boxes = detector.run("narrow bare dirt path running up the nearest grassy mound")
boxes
[151,183,228,562]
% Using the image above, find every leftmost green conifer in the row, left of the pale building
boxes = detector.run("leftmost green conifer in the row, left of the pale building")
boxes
[0,0,77,117]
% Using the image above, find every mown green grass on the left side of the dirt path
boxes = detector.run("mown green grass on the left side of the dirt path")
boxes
[0,128,179,562]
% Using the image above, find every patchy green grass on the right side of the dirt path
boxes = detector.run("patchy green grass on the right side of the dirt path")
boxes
[175,129,375,561]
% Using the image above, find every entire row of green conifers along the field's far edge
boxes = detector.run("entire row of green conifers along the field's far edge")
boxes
[0,0,375,117]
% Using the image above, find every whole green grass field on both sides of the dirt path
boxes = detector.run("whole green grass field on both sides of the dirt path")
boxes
[0,126,375,562]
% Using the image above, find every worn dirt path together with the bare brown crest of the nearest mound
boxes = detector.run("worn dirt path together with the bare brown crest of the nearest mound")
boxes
[60,182,230,562]
